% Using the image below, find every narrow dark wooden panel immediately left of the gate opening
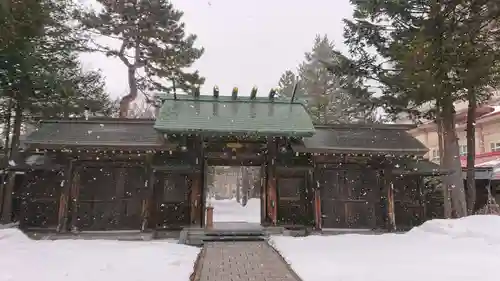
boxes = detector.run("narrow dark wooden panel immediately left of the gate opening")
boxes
[152,172,191,229]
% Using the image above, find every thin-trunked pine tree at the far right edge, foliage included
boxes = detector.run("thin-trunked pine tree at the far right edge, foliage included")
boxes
[455,0,500,214]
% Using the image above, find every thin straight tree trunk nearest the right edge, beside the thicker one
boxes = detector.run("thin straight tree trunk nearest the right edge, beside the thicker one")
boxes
[467,89,477,215]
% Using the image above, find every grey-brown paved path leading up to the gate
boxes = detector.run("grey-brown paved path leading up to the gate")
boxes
[195,241,300,281]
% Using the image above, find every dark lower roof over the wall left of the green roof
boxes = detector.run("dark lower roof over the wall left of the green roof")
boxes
[24,118,162,149]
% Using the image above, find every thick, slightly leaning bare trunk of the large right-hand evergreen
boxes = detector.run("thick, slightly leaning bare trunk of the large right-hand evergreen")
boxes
[441,98,467,218]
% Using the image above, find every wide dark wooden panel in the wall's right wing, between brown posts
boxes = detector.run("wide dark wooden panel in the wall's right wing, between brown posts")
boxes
[319,169,380,229]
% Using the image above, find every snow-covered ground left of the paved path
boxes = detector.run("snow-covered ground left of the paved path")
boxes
[0,228,199,281]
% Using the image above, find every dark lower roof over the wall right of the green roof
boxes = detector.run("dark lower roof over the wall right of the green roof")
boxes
[293,124,428,156]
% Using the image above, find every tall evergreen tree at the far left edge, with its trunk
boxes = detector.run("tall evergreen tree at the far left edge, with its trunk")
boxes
[0,0,117,222]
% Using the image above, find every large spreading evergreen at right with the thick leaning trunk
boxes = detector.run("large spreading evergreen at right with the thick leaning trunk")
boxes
[345,0,498,216]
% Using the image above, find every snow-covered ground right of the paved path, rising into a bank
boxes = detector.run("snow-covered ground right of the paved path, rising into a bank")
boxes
[271,216,500,281]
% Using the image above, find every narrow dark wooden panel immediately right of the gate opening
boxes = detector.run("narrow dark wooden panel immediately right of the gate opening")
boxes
[276,173,310,226]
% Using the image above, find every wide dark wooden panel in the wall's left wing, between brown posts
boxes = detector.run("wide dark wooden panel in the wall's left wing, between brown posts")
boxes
[73,167,147,231]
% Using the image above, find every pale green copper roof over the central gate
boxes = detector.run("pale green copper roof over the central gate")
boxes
[154,95,315,136]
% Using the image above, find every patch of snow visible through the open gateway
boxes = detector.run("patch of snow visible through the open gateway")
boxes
[211,198,260,223]
